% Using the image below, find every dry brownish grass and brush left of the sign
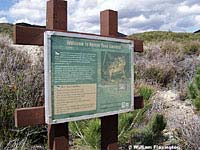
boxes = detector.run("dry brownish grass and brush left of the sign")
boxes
[0,35,46,149]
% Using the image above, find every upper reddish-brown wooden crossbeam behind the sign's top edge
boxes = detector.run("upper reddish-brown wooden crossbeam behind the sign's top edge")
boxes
[13,25,143,52]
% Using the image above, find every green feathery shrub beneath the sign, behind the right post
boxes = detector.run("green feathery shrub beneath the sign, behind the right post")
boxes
[69,107,153,149]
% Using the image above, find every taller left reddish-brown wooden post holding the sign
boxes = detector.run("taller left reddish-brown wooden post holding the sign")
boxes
[46,0,69,150]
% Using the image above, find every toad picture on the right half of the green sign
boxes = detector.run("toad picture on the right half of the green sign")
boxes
[101,51,131,84]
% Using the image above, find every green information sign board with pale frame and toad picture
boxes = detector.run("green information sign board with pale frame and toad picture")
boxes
[44,31,133,124]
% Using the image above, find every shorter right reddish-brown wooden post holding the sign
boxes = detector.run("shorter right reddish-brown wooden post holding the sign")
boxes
[100,10,118,150]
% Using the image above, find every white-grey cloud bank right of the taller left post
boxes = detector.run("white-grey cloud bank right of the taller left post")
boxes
[69,0,200,34]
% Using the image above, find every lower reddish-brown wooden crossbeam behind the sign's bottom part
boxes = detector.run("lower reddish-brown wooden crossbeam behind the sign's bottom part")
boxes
[15,96,144,127]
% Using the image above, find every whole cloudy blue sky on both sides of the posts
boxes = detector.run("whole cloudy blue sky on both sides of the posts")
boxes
[0,0,200,34]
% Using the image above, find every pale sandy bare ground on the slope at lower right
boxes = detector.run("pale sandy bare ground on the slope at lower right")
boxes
[149,90,200,150]
